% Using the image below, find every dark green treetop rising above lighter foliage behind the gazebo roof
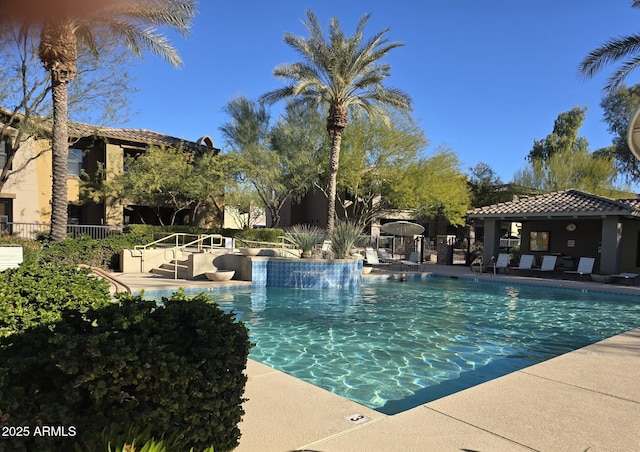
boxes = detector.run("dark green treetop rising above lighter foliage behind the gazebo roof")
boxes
[527,107,589,161]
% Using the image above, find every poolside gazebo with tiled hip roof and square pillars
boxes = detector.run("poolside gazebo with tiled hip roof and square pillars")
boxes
[468,190,640,274]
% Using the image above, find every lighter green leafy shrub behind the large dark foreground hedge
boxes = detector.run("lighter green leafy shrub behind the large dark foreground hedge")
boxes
[0,263,111,340]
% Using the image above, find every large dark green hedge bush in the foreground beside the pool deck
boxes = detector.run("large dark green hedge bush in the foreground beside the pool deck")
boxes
[0,292,250,451]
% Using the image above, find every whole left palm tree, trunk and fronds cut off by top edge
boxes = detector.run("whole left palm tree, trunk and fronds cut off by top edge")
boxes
[33,0,195,241]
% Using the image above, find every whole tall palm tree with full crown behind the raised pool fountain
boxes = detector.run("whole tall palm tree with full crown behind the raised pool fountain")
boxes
[261,10,411,233]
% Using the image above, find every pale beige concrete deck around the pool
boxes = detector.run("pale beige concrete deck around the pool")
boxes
[117,264,640,452]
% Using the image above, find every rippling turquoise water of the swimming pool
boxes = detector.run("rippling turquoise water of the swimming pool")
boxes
[148,277,640,414]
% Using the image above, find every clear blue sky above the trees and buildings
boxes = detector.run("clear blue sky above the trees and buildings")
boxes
[119,0,640,182]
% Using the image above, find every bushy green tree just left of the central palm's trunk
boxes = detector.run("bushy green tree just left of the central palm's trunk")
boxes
[220,97,324,227]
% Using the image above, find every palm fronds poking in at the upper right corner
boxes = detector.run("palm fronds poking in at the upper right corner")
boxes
[578,0,640,92]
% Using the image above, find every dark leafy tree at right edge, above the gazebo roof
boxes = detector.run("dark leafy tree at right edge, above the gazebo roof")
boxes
[596,84,640,182]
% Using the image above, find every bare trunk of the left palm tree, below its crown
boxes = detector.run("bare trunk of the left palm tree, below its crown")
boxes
[51,82,69,242]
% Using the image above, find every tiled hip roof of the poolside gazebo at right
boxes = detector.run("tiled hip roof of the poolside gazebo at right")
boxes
[467,190,640,218]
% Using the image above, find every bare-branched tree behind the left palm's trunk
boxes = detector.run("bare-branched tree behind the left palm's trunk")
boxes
[0,25,134,191]
